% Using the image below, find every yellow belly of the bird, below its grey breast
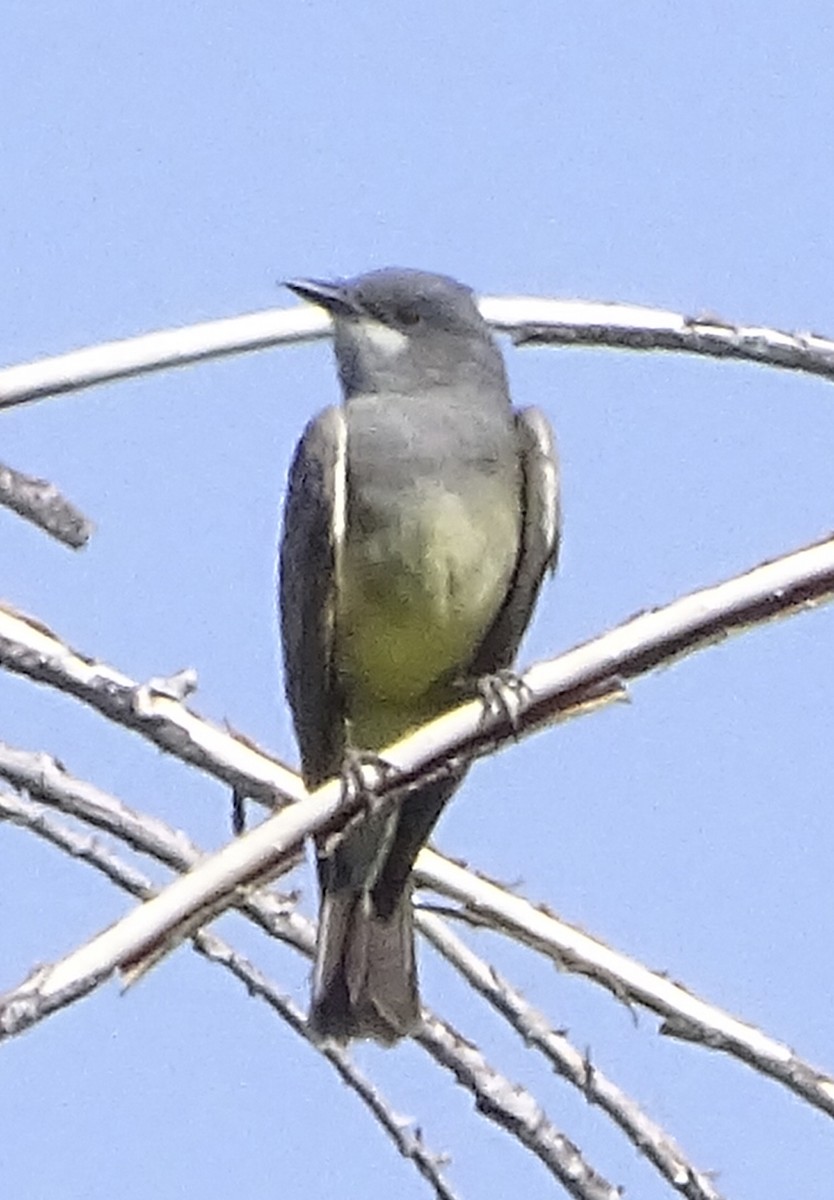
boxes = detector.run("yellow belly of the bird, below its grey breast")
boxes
[336,479,520,749]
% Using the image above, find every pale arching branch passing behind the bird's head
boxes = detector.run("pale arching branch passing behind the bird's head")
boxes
[0,296,834,408]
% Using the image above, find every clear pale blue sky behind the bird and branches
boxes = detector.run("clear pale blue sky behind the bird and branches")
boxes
[0,0,834,1200]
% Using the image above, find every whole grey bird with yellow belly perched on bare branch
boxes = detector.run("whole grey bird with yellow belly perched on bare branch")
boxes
[278,268,560,1045]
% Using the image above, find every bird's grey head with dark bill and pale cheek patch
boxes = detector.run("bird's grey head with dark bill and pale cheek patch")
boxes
[287,266,506,397]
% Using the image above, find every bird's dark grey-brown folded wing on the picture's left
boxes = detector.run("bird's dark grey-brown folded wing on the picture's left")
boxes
[280,408,346,787]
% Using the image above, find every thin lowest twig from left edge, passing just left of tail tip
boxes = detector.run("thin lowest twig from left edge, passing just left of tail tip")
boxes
[0,790,456,1200]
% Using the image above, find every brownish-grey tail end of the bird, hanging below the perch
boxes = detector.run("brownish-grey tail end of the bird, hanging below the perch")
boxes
[310,884,420,1045]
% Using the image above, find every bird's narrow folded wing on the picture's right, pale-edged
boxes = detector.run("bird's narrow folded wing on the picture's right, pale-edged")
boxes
[470,408,562,677]
